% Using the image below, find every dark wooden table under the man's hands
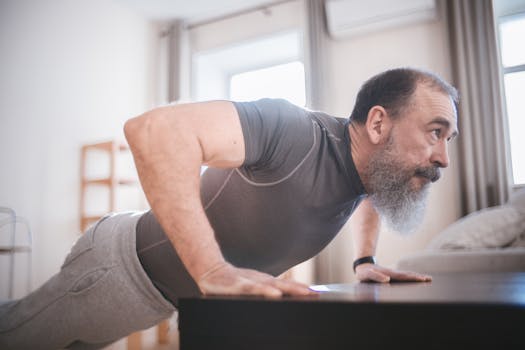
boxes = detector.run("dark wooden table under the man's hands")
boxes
[179,272,525,350]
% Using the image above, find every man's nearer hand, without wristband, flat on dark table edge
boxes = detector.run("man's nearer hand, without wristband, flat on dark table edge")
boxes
[197,263,317,298]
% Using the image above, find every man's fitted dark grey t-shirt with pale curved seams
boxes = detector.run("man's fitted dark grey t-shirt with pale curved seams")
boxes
[137,99,366,301]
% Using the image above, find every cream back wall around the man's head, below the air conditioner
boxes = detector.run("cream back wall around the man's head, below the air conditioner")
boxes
[190,1,460,282]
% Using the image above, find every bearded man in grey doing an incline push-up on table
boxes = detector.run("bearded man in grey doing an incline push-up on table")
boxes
[0,69,457,349]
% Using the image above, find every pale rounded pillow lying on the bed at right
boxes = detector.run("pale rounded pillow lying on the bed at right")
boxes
[427,205,525,250]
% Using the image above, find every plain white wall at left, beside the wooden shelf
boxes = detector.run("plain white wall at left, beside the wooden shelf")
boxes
[0,0,158,296]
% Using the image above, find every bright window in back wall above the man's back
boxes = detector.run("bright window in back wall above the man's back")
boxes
[192,31,306,106]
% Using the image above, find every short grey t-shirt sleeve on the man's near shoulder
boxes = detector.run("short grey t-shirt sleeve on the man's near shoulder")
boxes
[234,99,313,178]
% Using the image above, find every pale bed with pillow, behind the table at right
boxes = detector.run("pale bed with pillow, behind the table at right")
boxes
[397,189,525,274]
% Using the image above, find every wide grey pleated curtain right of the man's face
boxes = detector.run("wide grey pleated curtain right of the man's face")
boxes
[444,0,509,214]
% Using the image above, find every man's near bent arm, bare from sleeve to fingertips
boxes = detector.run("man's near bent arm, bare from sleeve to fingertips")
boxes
[124,101,309,296]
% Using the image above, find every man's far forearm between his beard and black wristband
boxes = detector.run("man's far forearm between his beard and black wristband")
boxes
[350,199,380,260]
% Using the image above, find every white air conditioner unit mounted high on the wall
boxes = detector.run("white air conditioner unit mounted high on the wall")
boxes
[325,0,437,39]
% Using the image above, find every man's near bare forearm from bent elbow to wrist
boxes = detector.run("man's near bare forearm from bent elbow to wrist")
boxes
[125,103,233,281]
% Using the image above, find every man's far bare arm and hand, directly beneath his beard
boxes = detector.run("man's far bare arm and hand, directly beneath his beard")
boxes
[350,199,432,282]
